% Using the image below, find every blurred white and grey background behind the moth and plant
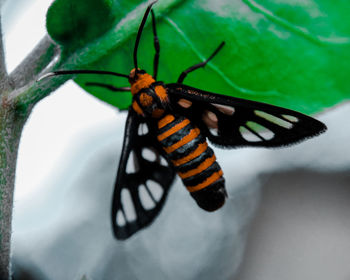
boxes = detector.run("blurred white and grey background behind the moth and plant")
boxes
[2,0,350,280]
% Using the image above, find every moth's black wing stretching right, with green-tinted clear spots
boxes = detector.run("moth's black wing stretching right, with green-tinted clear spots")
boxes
[166,84,327,148]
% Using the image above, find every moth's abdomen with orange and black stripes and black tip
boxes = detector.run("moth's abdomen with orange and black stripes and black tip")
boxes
[157,114,226,211]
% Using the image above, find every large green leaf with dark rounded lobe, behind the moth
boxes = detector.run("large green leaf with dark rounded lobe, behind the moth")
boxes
[47,0,350,113]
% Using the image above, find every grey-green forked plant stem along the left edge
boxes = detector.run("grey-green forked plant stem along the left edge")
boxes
[0,31,58,279]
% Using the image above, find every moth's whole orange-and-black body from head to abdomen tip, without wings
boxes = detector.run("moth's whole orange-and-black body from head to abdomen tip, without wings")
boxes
[131,70,227,211]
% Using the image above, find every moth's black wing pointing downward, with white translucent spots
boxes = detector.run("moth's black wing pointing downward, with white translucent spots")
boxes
[112,109,175,239]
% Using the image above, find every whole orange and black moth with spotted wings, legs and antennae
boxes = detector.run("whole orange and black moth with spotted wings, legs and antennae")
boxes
[40,2,326,239]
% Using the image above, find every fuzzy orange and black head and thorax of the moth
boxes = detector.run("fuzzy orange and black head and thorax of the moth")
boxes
[130,70,169,118]
